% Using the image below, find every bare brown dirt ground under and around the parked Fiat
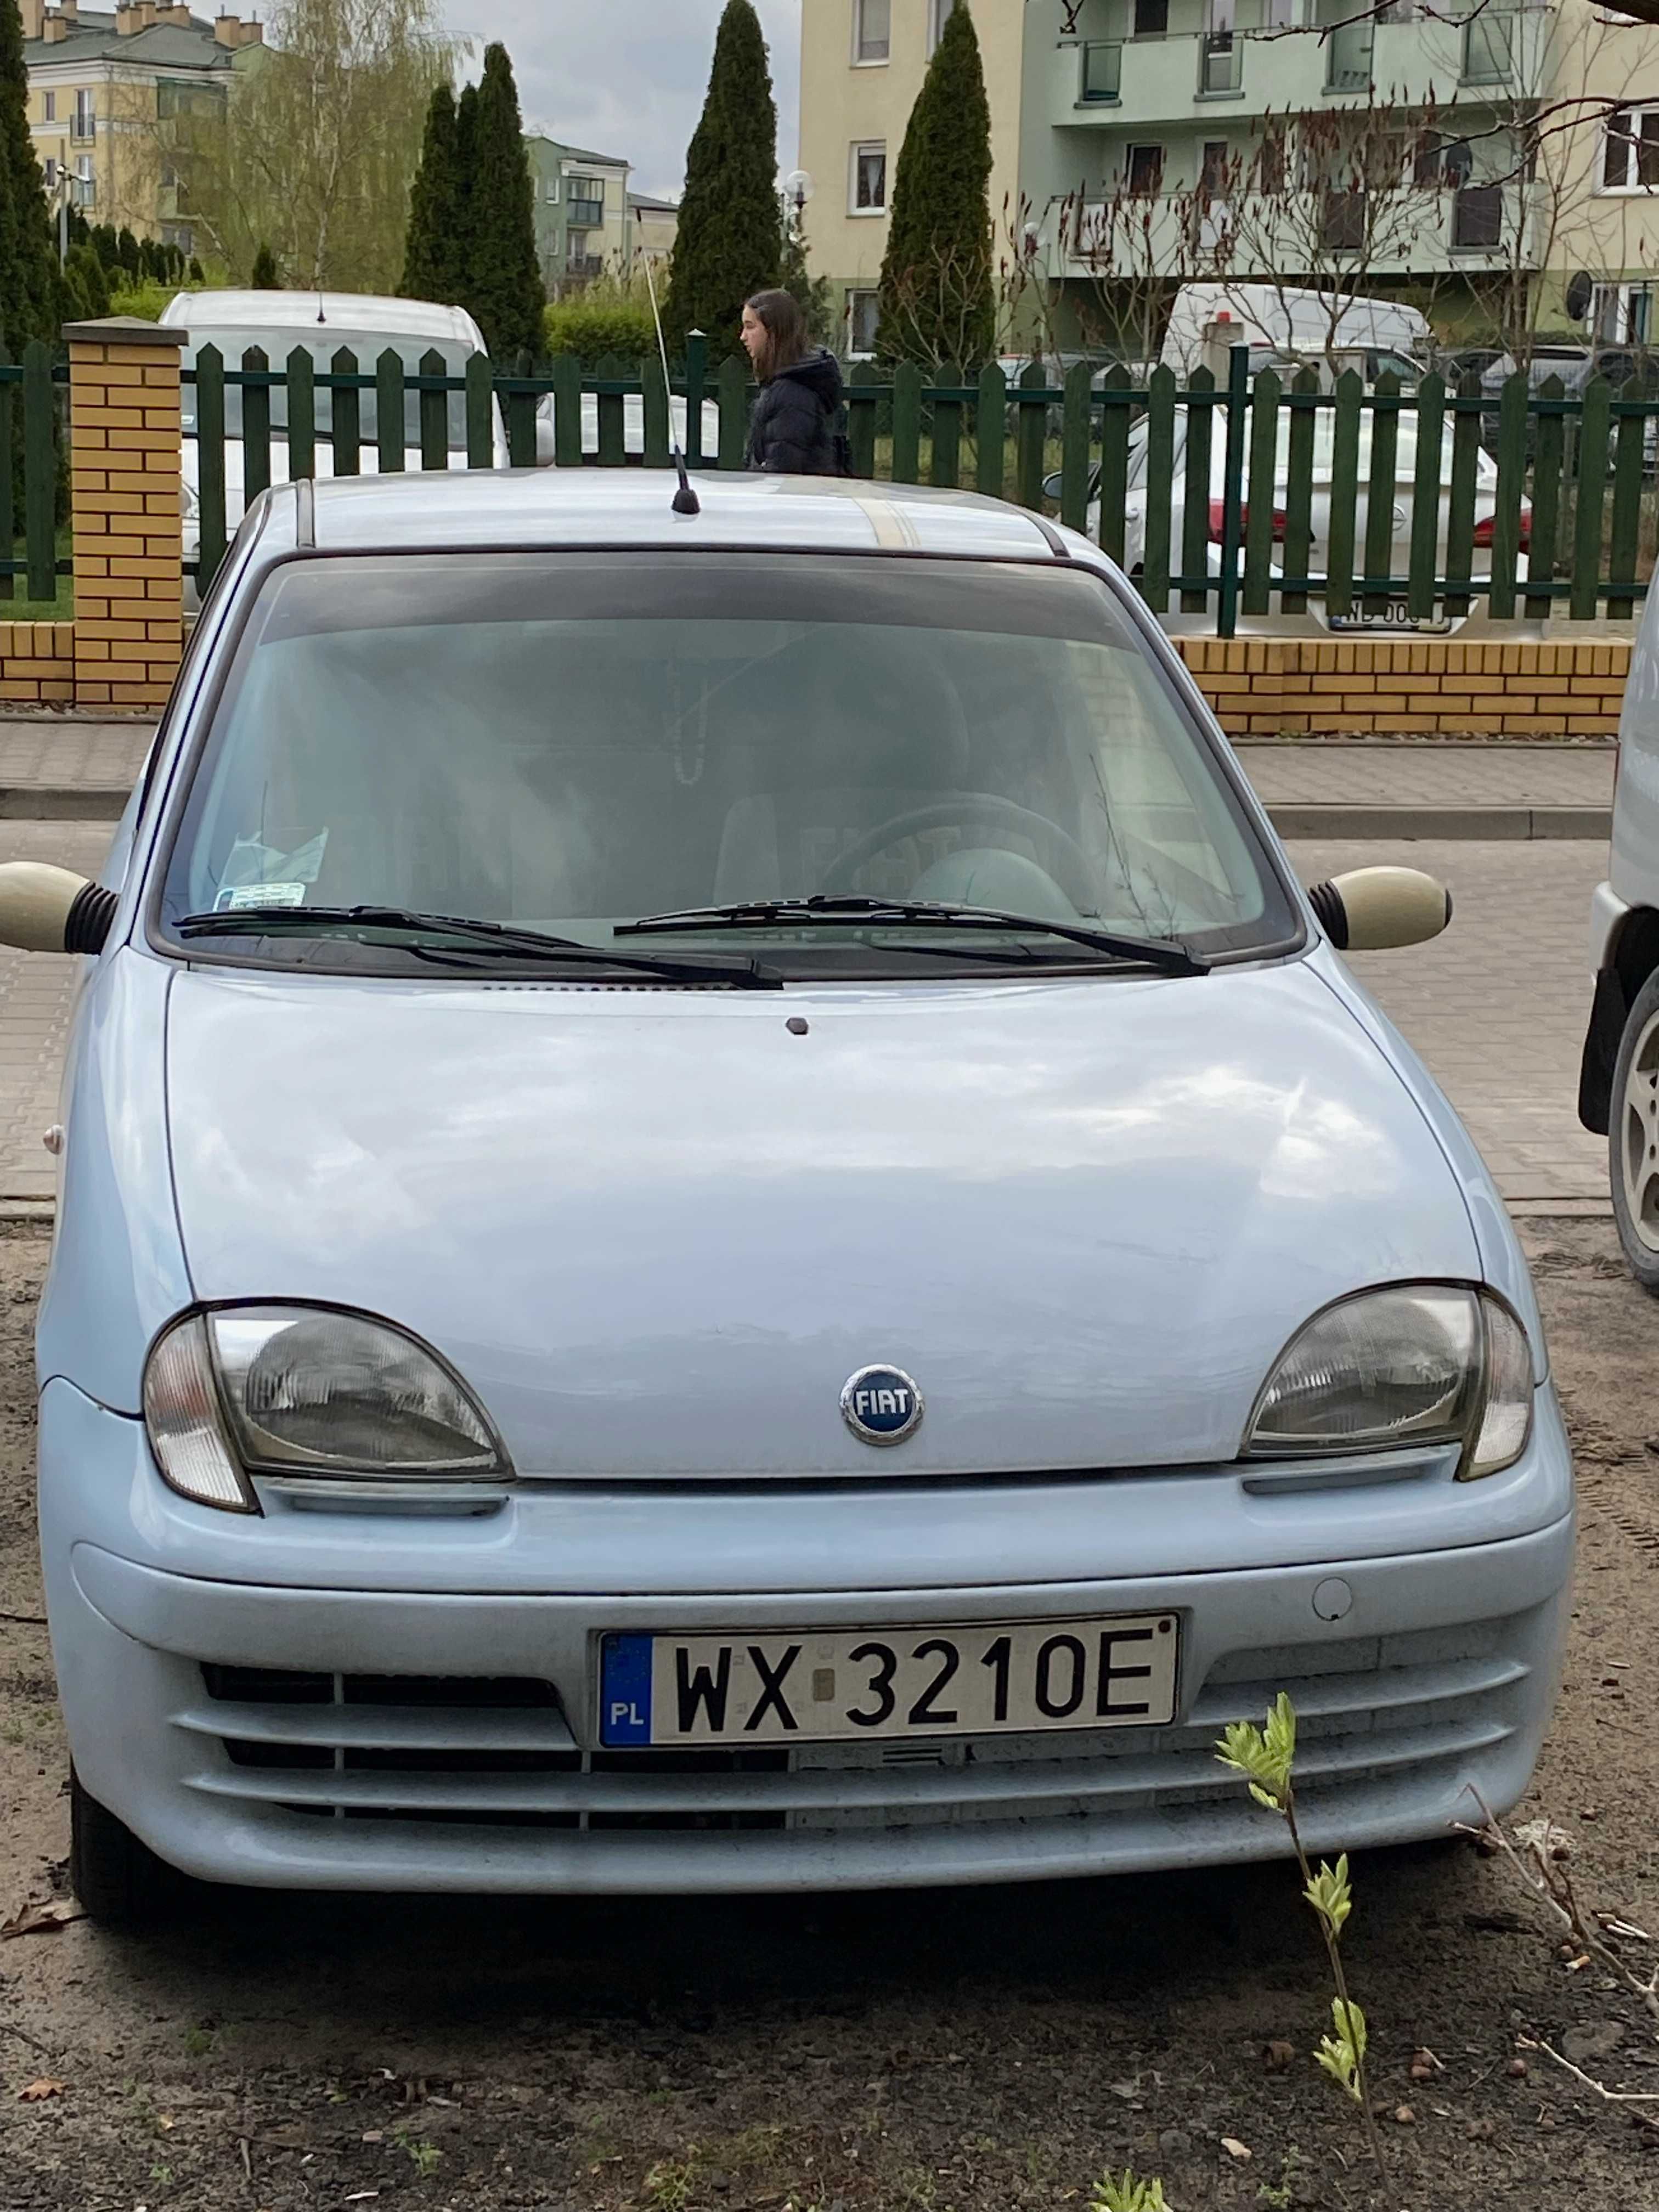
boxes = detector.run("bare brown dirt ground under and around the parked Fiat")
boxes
[0,1221,1659,2212]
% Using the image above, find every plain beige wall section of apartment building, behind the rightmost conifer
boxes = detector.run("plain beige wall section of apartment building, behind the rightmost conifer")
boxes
[801,0,1024,356]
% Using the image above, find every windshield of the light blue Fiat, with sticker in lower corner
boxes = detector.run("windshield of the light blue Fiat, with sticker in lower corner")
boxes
[161,553,1299,973]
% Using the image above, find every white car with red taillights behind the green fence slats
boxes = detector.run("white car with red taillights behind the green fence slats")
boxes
[1066,407,1533,633]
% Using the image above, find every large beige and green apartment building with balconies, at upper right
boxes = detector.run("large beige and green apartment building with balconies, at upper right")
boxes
[801,0,1659,352]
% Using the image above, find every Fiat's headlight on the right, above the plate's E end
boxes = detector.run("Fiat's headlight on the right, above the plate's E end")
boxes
[1245,1283,1533,1482]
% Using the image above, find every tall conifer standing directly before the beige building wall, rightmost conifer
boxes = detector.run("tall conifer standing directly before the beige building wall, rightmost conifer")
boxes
[876,0,995,369]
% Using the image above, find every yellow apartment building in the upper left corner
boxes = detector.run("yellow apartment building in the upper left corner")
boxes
[22,0,266,255]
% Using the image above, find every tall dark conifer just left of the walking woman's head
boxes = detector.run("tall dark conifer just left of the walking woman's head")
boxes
[666,0,783,360]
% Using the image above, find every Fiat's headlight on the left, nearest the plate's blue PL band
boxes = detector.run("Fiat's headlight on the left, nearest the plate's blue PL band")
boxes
[144,1305,513,1513]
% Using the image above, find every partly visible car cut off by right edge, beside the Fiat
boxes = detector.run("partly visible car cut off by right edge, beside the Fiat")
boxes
[1579,566,1659,1296]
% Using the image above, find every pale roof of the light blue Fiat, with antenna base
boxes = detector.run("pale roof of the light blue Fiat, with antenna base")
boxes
[287,469,1064,560]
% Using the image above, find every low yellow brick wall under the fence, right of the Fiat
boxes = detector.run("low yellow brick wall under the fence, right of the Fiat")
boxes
[1177,637,1630,737]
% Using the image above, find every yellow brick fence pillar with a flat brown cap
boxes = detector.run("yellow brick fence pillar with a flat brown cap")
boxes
[64,314,186,714]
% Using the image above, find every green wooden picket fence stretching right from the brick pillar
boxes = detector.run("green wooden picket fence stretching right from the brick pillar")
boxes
[166,343,1659,637]
